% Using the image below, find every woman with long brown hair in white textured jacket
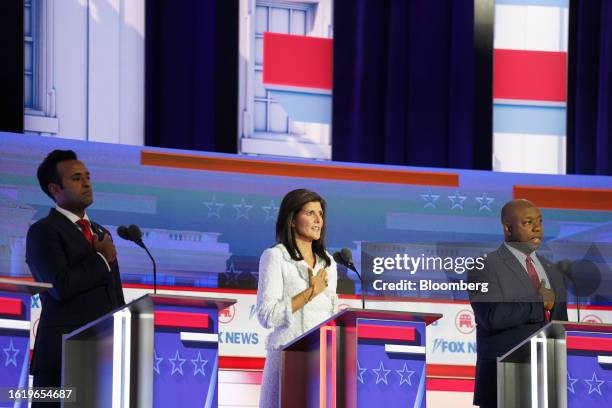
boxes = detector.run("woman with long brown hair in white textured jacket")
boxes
[257,189,338,408]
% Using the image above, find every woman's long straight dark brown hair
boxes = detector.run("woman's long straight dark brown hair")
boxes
[276,188,331,266]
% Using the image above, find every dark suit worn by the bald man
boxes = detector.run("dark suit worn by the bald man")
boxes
[468,244,567,407]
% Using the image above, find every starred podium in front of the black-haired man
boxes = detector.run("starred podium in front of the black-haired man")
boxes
[62,294,235,408]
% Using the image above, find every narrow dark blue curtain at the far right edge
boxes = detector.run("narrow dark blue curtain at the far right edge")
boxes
[567,0,612,175]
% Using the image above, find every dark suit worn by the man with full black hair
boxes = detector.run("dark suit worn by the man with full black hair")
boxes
[26,209,125,375]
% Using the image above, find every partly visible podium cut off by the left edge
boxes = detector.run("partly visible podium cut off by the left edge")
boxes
[0,278,53,398]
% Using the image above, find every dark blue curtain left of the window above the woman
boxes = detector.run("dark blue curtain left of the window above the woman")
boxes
[145,0,238,153]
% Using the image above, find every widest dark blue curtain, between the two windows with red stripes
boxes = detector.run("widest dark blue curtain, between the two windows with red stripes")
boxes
[332,0,492,170]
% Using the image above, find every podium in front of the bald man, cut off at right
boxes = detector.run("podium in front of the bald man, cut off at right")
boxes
[497,321,612,408]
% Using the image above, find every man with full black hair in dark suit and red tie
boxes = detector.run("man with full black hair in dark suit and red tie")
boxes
[26,150,125,407]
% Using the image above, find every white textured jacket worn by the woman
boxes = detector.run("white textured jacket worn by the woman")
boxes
[257,244,338,350]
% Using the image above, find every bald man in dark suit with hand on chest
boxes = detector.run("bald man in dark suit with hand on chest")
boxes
[469,200,567,408]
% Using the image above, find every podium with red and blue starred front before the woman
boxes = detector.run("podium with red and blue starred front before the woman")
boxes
[280,309,442,408]
